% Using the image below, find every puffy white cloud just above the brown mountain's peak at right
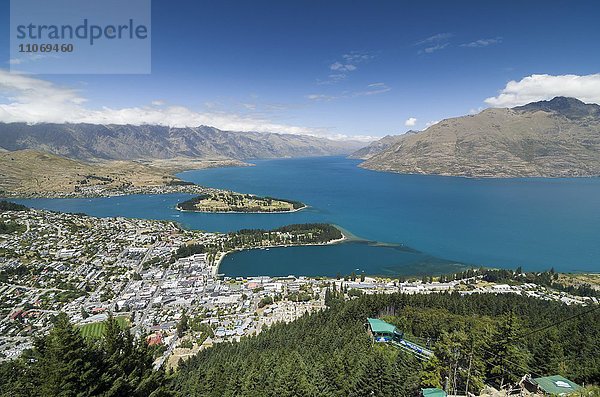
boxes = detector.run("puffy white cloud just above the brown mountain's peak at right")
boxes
[484,73,600,107]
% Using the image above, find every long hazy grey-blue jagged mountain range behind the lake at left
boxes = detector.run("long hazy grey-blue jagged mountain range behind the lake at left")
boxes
[0,123,361,160]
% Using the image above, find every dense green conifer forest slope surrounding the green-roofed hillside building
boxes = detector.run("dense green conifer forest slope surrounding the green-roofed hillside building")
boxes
[174,291,600,396]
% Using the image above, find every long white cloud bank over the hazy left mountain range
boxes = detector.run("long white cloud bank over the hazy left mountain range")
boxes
[0,69,346,137]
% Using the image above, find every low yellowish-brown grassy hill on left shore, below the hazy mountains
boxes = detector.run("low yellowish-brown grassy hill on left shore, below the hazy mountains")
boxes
[0,150,190,197]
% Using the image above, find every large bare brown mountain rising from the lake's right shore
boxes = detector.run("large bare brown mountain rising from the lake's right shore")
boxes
[361,97,600,177]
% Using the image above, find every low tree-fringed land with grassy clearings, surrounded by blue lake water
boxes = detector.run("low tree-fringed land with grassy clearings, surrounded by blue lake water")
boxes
[177,191,306,213]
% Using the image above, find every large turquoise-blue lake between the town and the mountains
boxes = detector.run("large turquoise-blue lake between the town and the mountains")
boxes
[13,157,600,276]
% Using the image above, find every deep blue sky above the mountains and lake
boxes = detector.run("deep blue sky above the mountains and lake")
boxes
[0,0,600,137]
